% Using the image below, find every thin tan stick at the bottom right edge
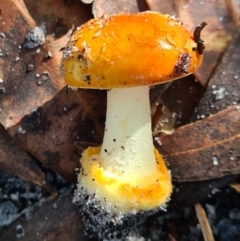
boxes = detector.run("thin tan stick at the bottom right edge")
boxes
[195,203,215,241]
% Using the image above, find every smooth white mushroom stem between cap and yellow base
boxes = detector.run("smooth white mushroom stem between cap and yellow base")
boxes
[100,86,156,179]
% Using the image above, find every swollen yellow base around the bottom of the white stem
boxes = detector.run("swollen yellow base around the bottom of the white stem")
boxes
[78,146,172,213]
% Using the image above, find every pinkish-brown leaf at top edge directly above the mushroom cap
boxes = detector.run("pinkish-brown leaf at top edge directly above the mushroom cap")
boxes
[92,0,148,18]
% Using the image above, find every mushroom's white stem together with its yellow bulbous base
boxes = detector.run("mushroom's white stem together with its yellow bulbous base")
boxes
[75,86,172,215]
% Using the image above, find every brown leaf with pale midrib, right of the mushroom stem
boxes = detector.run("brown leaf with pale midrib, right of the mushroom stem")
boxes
[158,106,240,181]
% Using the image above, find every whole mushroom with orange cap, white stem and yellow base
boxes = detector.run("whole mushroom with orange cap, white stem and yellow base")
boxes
[61,11,205,220]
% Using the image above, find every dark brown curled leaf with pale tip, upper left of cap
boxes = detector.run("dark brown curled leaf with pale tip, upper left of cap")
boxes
[24,0,92,62]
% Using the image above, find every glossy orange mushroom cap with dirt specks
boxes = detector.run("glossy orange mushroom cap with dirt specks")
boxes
[62,11,202,89]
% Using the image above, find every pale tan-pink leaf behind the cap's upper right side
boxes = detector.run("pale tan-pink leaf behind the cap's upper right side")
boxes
[146,0,236,85]
